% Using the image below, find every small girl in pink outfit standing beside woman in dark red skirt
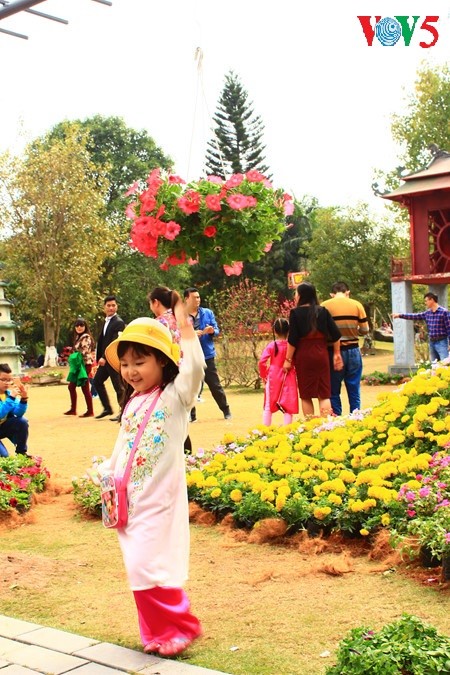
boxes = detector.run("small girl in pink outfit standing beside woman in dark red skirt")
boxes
[259,319,298,426]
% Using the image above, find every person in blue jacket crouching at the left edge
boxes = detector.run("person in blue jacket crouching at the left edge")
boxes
[0,363,28,457]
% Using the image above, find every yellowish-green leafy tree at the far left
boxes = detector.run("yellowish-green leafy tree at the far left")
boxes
[0,133,117,345]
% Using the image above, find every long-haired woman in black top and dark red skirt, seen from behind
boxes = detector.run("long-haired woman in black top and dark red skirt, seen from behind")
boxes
[283,281,343,417]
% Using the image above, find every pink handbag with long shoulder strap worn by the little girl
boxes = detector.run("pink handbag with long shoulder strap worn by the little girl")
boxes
[100,390,161,530]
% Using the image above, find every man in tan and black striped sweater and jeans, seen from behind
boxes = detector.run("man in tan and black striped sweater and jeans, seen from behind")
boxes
[322,281,369,415]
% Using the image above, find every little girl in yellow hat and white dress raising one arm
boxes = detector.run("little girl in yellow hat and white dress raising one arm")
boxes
[98,302,205,656]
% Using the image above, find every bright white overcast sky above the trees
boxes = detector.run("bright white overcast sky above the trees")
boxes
[0,0,450,210]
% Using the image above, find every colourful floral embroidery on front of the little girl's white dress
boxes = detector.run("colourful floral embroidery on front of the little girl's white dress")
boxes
[123,406,170,515]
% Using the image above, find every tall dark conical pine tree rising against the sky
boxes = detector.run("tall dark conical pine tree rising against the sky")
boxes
[206,71,269,178]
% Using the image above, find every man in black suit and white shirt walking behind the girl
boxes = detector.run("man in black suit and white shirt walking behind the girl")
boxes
[93,295,125,422]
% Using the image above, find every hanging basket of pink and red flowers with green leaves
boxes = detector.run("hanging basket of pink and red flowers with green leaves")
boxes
[126,169,294,275]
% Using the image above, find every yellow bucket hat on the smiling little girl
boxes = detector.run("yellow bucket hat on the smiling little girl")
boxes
[105,316,181,371]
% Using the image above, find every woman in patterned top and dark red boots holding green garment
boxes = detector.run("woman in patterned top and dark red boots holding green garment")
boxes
[64,318,95,417]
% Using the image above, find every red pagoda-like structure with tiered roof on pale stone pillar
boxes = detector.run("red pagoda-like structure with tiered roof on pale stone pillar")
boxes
[380,144,450,373]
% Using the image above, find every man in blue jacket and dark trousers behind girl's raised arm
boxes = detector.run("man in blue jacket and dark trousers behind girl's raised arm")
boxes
[184,287,231,422]
